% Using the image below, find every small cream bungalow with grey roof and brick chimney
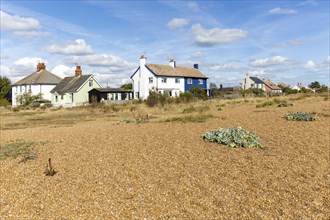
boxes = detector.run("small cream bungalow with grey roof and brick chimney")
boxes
[51,66,102,107]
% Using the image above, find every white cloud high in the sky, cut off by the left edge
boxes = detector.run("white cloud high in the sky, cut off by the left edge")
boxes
[0,10,41,31]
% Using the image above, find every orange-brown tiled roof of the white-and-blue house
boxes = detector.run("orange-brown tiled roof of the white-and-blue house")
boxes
[146,64,207,79]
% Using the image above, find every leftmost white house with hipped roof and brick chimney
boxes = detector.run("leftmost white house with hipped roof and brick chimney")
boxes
[12,63,62,106]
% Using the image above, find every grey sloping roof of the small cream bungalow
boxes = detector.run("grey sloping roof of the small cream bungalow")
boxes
[50,75,91,95]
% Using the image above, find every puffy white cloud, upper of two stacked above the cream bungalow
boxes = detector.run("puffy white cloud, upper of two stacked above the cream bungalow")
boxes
[46,39,93,55]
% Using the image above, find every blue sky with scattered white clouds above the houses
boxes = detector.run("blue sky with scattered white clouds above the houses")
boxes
[0,0,330,87]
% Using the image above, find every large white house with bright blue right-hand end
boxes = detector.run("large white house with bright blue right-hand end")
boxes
[131,56,209,99]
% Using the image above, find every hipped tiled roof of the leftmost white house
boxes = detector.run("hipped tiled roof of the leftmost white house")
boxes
[13,69,62,86]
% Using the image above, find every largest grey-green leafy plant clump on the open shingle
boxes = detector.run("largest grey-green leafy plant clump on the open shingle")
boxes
[202,127,262,148]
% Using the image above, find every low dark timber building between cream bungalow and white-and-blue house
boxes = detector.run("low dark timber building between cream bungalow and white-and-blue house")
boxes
[88,88,133,102]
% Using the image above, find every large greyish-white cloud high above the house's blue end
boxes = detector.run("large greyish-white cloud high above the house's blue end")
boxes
[191,24,247,47]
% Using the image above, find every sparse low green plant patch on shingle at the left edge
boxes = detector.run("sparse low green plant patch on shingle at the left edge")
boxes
[0,140,34,160]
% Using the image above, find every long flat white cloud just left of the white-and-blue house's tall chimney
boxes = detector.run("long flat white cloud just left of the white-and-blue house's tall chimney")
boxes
[67,54,135,70]
